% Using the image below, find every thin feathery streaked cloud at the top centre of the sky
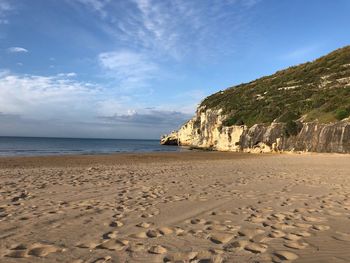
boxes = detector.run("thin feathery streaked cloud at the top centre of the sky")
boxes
[70,0,260,60]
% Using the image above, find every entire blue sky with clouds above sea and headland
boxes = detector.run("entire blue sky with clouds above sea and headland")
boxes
[0,0,350,139]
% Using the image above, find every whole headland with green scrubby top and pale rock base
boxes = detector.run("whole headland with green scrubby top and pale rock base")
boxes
[161,47,350,153]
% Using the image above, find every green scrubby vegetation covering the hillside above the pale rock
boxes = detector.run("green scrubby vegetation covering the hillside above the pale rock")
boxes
[201,46,350,127]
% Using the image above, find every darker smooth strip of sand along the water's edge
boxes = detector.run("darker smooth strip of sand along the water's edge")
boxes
[0,150,350,169]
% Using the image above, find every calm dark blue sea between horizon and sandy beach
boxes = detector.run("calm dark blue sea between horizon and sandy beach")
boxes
[0,137,185,156]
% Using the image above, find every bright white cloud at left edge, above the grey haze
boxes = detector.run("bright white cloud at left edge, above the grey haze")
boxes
[0,71,101,119]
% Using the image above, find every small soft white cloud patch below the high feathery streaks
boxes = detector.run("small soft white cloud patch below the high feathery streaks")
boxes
[98,50,158,88]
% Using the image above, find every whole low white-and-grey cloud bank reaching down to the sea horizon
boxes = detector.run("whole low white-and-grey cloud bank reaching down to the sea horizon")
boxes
[0,70,190,138]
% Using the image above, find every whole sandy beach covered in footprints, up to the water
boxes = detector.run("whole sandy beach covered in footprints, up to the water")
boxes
[0,152,350,263]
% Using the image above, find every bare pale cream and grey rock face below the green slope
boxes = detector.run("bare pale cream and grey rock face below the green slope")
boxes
[161,107,350,153]
